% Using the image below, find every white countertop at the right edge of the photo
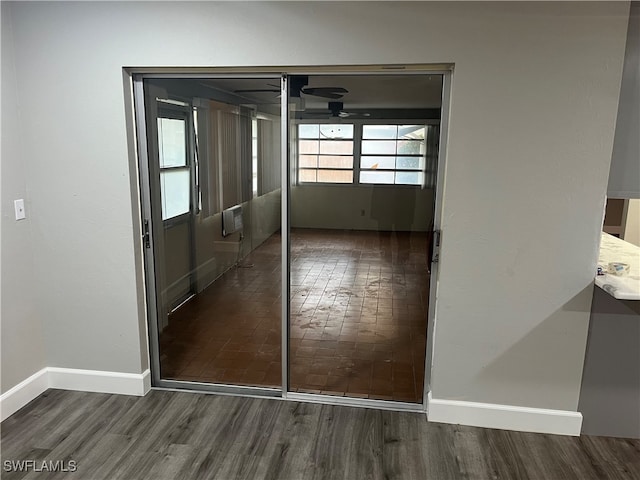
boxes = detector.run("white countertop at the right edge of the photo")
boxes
[596,232,640,300]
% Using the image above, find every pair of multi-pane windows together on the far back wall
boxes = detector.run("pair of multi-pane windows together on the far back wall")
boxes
[297,121,439,187]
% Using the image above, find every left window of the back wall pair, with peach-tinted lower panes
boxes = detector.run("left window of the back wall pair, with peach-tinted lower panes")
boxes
[298,124,354,183]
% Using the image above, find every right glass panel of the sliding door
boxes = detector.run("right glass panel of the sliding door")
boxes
[288,75,442,403]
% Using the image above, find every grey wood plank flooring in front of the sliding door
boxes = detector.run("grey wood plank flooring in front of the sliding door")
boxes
[1,390,640,480]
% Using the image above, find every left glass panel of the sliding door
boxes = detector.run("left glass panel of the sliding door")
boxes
[144,77,282,388]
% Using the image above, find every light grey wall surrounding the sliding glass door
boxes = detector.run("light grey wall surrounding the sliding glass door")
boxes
[3,2,628,410]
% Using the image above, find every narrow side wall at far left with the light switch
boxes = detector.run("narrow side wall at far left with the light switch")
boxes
[0,3,47,393]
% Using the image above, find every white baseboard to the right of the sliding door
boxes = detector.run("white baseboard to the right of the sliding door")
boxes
[427,392,582,436]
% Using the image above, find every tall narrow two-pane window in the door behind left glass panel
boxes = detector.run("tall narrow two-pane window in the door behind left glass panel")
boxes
[158,111,191,220]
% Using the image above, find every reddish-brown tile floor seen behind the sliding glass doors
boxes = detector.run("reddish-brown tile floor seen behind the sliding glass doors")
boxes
[160,229,429,402]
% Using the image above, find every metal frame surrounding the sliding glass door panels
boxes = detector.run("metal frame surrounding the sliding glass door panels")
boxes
[124,64,453,412]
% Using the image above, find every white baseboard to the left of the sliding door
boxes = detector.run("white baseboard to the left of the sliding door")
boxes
[0,367,151,421]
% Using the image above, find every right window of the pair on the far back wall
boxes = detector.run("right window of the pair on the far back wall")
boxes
[360,125,426,185]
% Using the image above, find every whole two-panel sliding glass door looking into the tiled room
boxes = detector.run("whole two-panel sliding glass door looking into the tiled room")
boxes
[134,67,444,410]
